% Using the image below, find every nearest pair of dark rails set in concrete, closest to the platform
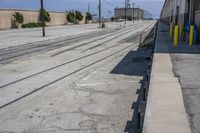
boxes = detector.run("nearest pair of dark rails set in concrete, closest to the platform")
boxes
[0,21,155,109]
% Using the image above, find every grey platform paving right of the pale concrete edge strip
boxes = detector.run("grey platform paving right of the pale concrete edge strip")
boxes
[168,32,200,133]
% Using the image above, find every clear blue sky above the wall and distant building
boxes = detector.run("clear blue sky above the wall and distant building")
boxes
[0,0,164,18]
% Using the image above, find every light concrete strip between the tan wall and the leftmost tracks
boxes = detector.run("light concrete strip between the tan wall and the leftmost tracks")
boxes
[0,22,133,49]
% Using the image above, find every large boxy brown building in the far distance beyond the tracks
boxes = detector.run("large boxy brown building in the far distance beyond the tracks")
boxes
[115,8,144,20]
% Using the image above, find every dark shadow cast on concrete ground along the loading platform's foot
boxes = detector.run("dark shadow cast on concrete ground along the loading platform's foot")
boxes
[111,48,152,133]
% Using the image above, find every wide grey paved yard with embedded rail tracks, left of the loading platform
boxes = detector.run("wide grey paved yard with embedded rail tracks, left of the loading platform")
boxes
[0,21,156,133]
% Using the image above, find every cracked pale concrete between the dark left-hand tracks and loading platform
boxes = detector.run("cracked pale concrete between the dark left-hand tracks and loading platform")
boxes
[0,21,155,133]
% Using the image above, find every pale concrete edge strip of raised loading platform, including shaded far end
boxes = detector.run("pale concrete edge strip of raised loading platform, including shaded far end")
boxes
[143,23,192,133]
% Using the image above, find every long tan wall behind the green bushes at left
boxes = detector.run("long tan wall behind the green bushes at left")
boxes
[0,9,85,29]
